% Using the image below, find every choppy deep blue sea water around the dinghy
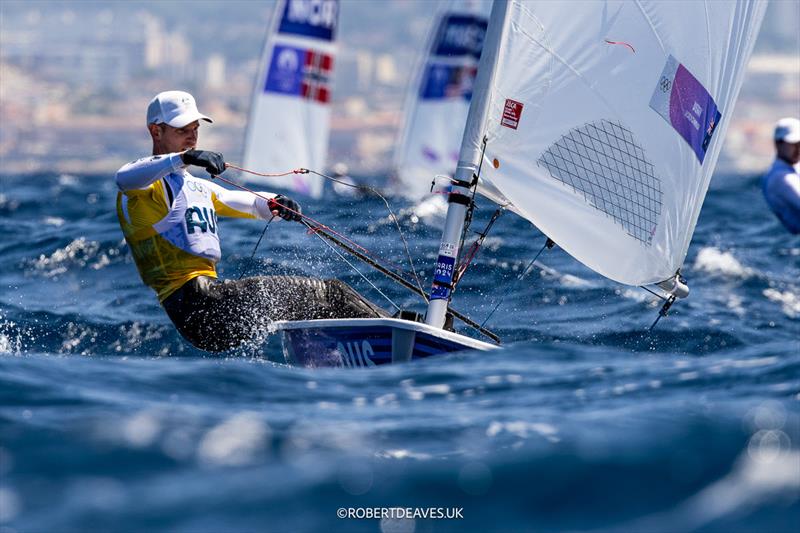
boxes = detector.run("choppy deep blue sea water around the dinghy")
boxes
[0,171,800,533]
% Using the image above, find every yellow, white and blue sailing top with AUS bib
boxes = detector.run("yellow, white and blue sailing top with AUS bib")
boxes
[116,153,274,302]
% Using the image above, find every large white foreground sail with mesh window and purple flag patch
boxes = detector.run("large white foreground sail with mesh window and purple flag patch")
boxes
[472,0,766,285]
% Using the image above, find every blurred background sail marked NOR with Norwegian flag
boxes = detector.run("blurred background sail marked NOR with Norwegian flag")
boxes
[239,0,339,198]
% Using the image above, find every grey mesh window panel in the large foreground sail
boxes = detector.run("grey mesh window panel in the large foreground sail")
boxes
[537,120,662,246]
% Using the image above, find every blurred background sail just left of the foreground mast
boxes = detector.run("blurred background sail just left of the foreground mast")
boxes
[395,0,489,198]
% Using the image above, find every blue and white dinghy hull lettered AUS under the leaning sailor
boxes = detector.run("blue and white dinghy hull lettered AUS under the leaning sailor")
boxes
[274,318,497,368]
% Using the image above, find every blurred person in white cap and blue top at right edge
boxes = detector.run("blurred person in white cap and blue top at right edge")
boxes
[761,118,800,234]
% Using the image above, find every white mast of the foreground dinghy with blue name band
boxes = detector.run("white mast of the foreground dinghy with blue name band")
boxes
[425,0,508,328]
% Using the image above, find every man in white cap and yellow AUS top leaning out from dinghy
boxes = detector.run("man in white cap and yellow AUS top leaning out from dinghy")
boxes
[116,91,386,352]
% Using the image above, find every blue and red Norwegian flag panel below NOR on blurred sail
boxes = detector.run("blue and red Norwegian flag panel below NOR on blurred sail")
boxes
[264,45,333,104]
